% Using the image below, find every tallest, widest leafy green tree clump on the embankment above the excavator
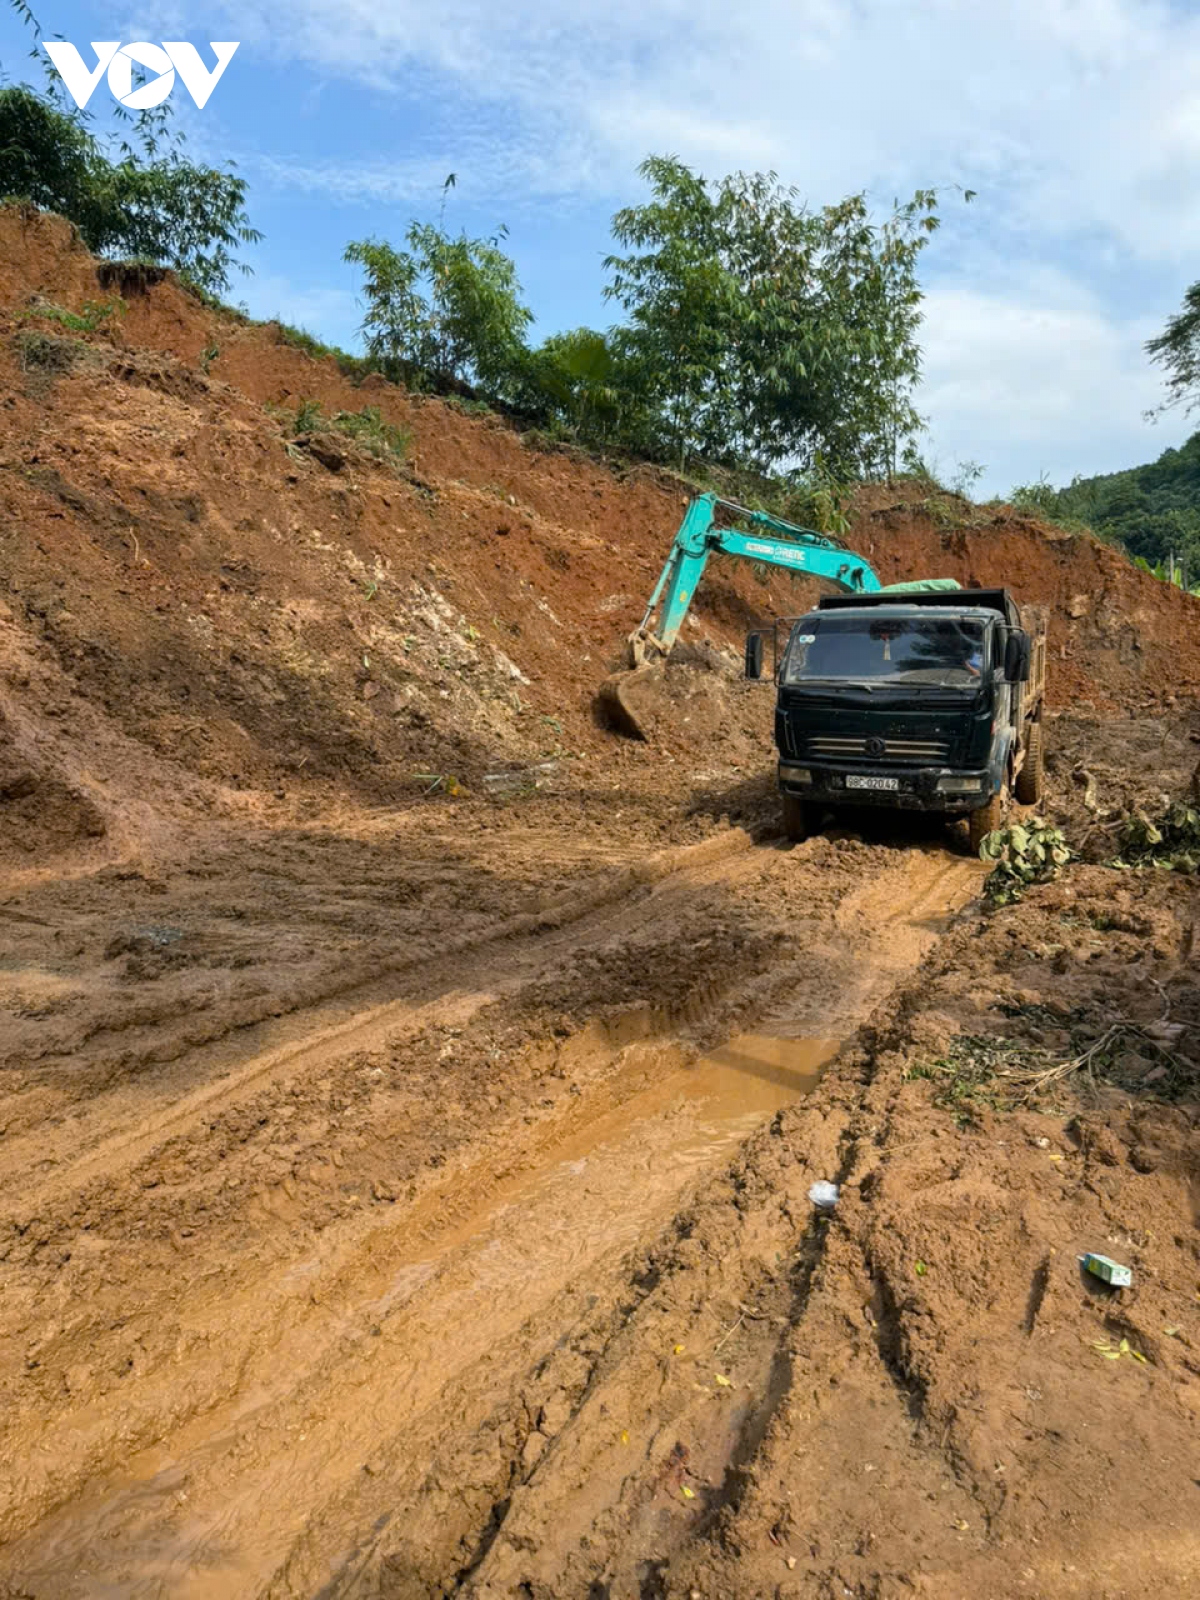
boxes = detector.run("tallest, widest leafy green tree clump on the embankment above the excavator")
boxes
[605,157,947,475]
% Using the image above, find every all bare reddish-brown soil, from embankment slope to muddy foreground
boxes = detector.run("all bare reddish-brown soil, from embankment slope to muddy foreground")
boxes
[0,210,1200,1600]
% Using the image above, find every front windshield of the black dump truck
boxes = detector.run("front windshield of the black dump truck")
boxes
[779,613,984,688]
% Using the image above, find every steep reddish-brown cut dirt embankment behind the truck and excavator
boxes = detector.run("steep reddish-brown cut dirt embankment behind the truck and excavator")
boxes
[0,208,1200,876]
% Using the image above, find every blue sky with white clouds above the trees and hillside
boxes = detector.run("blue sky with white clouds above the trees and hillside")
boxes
[0,0,1200,494]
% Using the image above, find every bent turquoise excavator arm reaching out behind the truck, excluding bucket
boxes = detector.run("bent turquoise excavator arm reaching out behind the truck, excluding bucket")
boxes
[629,494,880,667]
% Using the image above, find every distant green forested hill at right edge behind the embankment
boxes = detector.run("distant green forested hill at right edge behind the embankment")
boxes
[1013,434,1200,582]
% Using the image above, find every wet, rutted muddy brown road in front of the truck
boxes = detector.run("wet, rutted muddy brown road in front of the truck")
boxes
[0,793,979,1597]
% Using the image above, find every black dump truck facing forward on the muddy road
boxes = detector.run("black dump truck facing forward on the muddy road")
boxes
[746,589,1045,850]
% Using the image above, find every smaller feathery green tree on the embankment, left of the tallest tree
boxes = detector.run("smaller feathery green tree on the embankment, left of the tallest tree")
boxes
[346,222,533,398]
